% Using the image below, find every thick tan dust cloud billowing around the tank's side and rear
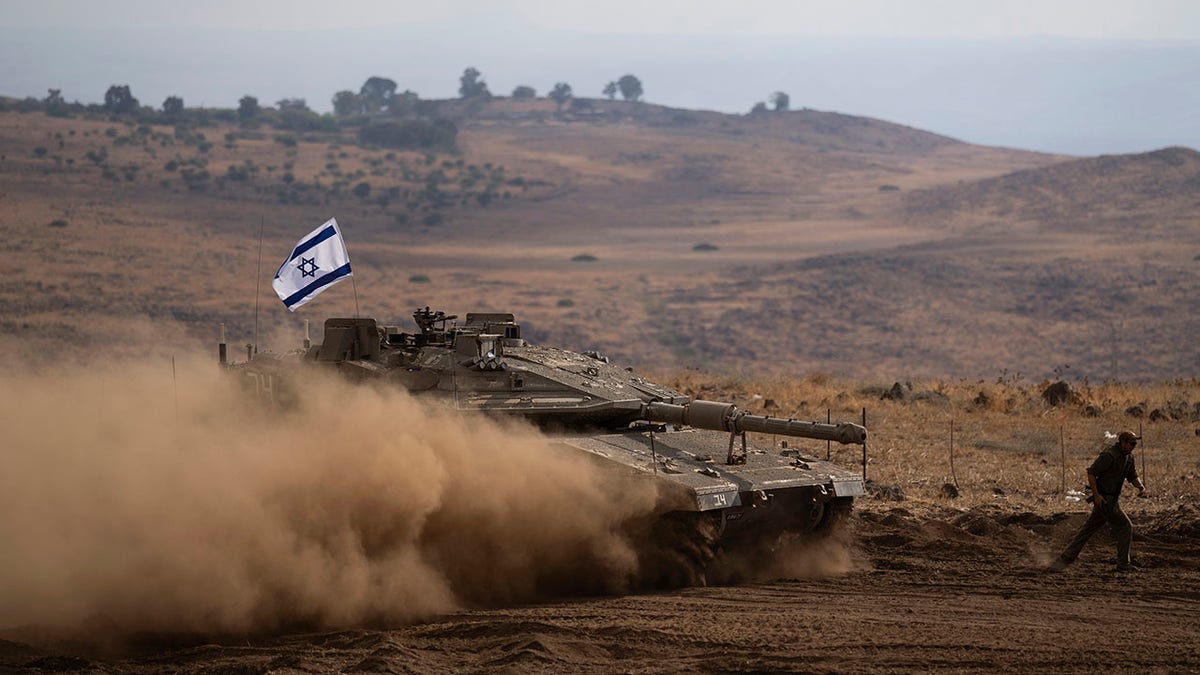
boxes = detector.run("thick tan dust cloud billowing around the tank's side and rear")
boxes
[0,357,658,634]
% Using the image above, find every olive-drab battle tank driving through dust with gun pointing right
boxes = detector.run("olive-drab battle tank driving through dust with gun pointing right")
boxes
[220,307,866,585]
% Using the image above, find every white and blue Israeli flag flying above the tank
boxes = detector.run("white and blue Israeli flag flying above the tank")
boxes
[271,219,353,311]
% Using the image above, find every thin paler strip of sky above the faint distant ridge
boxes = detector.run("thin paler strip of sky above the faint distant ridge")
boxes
[9,0,1200,40]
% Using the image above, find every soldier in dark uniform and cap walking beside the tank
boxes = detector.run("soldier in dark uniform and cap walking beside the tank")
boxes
[1049,431,1146,572]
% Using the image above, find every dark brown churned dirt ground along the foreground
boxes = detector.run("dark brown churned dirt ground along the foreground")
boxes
[0,500,1200,673]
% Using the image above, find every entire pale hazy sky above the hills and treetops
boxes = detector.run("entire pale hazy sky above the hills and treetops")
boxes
[0,0,1200,154]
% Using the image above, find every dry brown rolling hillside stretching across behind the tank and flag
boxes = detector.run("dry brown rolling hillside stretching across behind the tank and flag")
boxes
[0,100,1200,380]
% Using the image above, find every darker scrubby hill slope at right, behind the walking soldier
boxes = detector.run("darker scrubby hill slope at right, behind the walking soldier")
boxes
[652,148,1200,378]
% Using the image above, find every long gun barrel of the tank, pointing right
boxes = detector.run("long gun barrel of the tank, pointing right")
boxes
[642,400,866,446]
